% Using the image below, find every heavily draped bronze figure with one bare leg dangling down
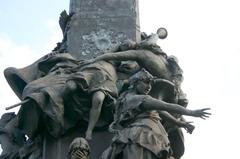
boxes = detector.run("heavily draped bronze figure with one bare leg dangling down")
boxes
[9,53,118,140]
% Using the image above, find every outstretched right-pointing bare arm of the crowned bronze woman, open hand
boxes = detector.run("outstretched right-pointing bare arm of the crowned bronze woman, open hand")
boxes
[141,96,211,119]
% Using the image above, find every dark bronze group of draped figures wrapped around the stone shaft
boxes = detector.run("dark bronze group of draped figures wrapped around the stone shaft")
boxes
[0,3,211,159]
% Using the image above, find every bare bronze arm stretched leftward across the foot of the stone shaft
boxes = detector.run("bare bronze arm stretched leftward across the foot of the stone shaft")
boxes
[95,50,142,61]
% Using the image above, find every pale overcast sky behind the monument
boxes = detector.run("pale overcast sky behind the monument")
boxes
[0,0,240,159]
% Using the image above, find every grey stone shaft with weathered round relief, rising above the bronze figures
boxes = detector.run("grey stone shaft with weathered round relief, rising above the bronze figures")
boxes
[67,0,140,59]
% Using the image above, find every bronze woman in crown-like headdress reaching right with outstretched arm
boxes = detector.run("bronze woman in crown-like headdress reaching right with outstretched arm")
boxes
[102,70,210,159]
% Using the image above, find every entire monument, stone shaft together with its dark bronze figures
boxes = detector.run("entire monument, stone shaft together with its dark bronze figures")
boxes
[0,0,211,159]
